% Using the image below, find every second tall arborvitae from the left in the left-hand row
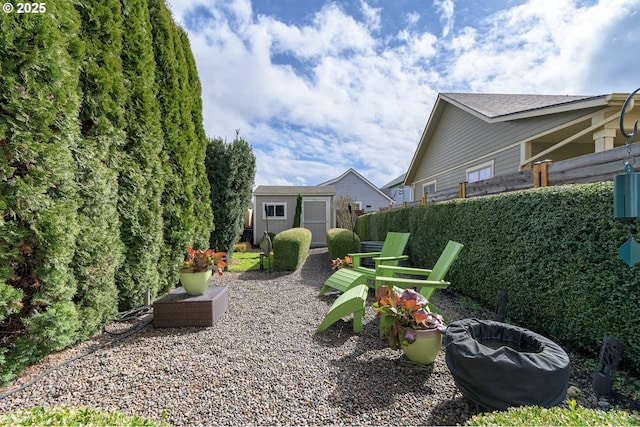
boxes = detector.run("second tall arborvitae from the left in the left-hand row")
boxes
[72,0,126,338]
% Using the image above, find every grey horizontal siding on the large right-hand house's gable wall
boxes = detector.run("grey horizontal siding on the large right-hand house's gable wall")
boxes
[414,103,595,200]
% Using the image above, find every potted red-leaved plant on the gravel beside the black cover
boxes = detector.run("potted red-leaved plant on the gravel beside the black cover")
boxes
[373,286,446,364]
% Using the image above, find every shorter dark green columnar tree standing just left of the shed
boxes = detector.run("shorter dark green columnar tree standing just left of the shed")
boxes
[206,136,256,254]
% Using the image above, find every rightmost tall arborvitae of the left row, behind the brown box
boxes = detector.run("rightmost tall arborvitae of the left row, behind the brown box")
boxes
[148,0,213,290]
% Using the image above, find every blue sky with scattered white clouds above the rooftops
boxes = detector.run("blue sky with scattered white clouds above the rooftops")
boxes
[166,0,640,188]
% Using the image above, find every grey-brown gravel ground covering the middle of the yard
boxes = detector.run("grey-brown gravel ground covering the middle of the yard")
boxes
[0,249,636,425]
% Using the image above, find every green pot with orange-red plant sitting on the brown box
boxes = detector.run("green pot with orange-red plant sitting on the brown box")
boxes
[180,246,227,295]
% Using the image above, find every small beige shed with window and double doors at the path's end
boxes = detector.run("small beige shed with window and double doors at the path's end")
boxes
[253,185,336,247]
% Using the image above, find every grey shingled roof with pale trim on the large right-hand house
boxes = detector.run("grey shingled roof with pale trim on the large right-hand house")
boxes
[405,93,628,183]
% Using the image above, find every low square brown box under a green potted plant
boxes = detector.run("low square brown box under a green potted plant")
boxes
[153,286,229,328]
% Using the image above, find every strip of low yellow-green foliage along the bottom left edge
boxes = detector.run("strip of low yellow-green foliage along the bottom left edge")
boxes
[0,406,170,426]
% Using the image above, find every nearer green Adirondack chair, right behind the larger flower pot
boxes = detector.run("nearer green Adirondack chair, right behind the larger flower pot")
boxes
[376,240,464,299]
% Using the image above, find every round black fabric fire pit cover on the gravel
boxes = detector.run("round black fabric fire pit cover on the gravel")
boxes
[444,319,570,410]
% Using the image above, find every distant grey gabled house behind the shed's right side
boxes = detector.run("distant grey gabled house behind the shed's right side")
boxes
[320,168,393,213]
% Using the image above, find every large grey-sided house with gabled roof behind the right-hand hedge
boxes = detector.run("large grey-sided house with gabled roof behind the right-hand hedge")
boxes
[404,93,640,200]
